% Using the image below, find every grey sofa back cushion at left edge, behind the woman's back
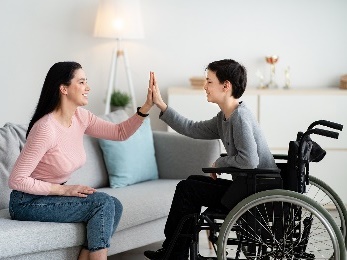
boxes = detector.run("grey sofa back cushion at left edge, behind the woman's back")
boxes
[0,123,27,210]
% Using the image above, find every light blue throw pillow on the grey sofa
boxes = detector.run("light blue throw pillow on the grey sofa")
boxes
[99,118,158,188]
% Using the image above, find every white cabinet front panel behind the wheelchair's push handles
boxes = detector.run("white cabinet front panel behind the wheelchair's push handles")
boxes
[258,90,347,149]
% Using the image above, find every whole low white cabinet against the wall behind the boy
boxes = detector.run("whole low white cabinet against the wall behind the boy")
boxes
[168,87,347,204]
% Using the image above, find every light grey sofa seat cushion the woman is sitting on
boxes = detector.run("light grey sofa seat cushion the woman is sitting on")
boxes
[0,180,179,258]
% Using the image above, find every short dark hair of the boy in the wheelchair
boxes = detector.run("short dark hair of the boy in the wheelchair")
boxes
[206,59,247,98]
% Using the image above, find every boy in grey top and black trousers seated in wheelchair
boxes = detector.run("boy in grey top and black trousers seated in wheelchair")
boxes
[145,59,277,260]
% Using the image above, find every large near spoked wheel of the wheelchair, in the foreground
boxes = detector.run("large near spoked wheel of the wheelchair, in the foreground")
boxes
[217,190,346,260]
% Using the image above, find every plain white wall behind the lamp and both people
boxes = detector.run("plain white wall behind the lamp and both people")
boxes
[0,0,347,130]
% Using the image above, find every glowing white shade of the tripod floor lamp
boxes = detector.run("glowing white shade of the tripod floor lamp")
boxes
[94,0,144,39]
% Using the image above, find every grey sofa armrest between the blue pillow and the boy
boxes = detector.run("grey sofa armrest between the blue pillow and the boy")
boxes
[153,131,221,179]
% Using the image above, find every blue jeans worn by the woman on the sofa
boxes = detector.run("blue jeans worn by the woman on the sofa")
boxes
[9,190,123,251]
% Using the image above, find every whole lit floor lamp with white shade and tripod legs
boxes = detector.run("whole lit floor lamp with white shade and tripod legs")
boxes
[94,0,143,114]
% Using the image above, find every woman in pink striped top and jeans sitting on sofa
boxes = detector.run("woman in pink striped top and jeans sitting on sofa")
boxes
[9,62,153,260]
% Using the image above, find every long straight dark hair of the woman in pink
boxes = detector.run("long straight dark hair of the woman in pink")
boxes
[26,61,82,137]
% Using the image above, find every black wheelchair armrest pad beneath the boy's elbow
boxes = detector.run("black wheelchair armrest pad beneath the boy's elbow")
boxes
[202,167,281,176]
